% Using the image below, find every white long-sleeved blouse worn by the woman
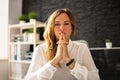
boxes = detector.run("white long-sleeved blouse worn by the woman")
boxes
[25,41,100,80]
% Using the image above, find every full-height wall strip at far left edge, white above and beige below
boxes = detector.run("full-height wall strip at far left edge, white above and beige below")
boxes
[0,0,9,80]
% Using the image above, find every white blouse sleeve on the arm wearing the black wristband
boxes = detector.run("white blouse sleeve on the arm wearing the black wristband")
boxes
[70,43,100,80]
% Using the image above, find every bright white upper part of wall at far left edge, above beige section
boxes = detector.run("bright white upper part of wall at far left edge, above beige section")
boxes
[0,0,9,59]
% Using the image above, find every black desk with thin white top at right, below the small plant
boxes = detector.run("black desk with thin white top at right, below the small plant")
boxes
[90,47,120,80]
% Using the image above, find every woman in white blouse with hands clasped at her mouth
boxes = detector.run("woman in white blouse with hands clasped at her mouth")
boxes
[25,9,100,80]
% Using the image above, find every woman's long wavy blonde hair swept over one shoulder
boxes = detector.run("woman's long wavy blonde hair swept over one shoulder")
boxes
[44,9,76,61]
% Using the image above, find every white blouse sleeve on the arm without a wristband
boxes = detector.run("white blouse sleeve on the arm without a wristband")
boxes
[25,47,57,80]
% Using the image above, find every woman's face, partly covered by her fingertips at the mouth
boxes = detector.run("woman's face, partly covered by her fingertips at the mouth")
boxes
[54,13,72,41]
